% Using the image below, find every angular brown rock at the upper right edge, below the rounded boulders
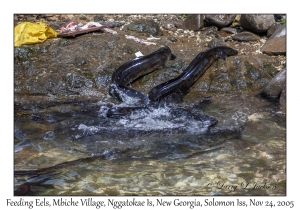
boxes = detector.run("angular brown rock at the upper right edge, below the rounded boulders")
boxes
[261,24,286,55]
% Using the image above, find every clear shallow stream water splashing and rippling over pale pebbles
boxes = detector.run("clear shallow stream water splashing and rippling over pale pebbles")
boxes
[14,95,286,195]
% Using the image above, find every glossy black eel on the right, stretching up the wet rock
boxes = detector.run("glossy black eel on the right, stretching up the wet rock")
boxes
[148,46,238,101]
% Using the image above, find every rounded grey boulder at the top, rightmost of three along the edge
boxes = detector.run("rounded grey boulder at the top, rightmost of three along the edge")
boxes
[240,14,275,33]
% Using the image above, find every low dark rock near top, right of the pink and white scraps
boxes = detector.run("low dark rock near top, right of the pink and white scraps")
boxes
[123,20,163,36]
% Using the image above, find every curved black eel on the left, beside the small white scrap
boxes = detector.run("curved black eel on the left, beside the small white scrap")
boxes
[109,46,176,104]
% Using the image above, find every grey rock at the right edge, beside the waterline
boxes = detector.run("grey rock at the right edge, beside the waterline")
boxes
[260,68,286,98]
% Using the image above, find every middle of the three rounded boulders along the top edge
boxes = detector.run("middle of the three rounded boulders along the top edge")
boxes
[205,14,236,28]
